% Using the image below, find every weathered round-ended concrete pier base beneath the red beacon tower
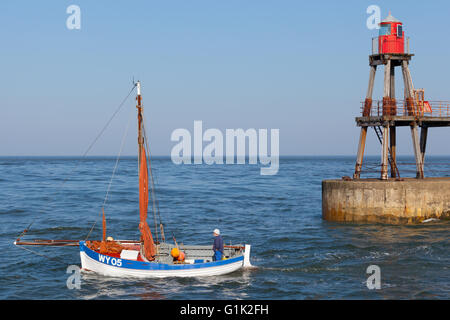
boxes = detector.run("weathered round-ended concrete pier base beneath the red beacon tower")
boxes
[322,178,450,224]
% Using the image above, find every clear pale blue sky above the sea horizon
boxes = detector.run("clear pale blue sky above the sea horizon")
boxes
[0,0,450,156]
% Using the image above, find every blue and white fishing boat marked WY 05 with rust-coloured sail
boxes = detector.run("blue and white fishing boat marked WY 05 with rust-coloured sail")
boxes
[14,81,252,277]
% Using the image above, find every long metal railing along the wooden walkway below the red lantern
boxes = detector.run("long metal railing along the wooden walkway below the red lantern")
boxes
[361,100,450,117]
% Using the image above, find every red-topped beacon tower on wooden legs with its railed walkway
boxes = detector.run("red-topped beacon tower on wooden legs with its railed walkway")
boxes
[353,13,450,180]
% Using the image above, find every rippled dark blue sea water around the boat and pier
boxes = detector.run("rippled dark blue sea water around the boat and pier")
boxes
[0,156,450,299]
